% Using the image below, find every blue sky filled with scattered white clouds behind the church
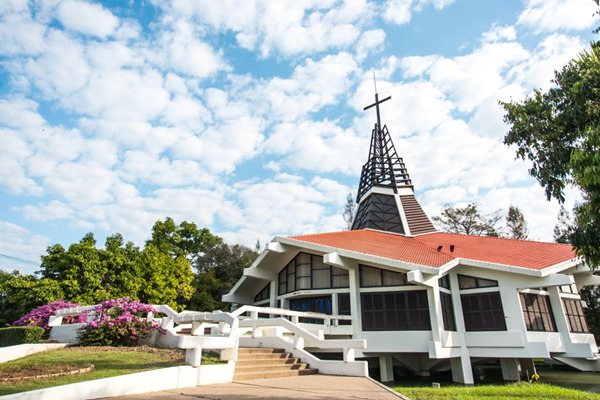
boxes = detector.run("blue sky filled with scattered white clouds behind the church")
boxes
[0,0,597,273]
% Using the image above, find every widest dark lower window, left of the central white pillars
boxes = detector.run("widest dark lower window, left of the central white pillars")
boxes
[360,290,431,331]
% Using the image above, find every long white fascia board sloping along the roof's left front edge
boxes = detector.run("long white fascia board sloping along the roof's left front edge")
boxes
[278,237,440,275]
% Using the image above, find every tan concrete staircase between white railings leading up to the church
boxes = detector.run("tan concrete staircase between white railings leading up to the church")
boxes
[233,348,319,381]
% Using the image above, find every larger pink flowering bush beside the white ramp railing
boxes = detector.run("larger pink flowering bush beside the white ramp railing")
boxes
[79,297,164,346]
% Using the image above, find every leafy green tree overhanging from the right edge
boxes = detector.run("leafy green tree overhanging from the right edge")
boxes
[501,42,600,267]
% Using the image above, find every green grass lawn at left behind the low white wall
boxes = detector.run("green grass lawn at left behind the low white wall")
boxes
[0,347,218,396]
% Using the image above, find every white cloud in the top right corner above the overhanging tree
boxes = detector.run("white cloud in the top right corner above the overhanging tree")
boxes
[517,0,598,33]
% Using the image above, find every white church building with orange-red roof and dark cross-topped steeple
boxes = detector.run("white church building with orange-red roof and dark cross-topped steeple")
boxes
[223,94,600,384]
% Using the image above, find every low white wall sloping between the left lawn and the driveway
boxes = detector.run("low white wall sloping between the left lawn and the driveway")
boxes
[2,363,235,400]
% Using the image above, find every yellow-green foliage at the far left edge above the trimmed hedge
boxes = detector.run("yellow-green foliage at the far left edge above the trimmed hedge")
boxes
[0,271,63,327]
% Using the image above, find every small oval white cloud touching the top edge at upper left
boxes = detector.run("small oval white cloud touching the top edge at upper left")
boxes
[56,0,119,38]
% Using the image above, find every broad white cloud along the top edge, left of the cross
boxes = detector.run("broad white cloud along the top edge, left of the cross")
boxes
[161,0,373,57]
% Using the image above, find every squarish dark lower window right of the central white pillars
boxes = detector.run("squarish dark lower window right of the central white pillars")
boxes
[460,292,506,331]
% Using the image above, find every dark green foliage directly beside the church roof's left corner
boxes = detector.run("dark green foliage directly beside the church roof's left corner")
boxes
[190,242,258,311]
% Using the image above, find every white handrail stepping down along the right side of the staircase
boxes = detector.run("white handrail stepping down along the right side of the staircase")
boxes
[239,318,367,362]
